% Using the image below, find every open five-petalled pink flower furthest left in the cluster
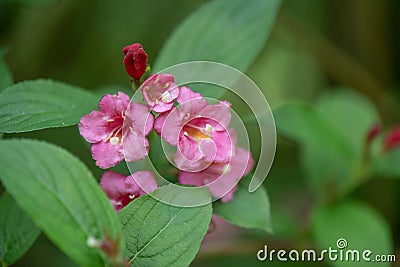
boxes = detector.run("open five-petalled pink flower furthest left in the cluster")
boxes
[79,92,154,169]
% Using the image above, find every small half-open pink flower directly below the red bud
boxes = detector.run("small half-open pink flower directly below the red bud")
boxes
[142,74,179,113]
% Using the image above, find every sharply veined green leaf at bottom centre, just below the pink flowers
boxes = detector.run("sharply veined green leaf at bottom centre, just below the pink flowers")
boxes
[119,186,212,267]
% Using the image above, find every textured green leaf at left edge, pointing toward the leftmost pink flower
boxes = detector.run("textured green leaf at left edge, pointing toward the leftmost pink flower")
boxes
[0,80,98,133]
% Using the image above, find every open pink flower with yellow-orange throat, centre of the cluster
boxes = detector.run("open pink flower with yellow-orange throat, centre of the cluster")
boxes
[154,87,234,171]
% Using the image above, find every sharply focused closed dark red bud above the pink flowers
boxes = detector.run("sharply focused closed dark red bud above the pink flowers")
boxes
[122,43,147,80]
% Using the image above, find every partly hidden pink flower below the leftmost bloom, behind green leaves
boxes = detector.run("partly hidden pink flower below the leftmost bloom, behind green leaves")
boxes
[100,171,157,211]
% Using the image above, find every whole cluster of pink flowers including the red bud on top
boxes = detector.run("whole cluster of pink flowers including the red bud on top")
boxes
[79,44,254,211]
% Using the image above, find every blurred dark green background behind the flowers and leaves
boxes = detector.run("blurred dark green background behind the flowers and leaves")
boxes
[0,0,400,266]
